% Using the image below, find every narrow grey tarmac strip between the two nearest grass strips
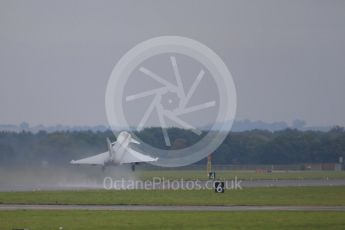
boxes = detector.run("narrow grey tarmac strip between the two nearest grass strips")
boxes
[0,204,345,212]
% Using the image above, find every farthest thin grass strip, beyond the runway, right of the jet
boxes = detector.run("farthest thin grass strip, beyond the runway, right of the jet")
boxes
[134,168,345,180]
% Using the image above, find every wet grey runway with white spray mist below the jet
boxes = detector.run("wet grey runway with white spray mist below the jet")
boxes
[0,166,345,192]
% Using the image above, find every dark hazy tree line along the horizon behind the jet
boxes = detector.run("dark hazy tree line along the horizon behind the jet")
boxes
[0,127,345,165]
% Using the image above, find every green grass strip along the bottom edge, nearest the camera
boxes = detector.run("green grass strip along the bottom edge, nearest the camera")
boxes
[0,211,345,230]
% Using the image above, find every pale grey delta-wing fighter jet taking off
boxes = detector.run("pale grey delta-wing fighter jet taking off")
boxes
[70,131,158,171]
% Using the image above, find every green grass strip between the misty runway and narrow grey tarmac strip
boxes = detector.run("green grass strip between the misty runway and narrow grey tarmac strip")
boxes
[0,186,345,205]
